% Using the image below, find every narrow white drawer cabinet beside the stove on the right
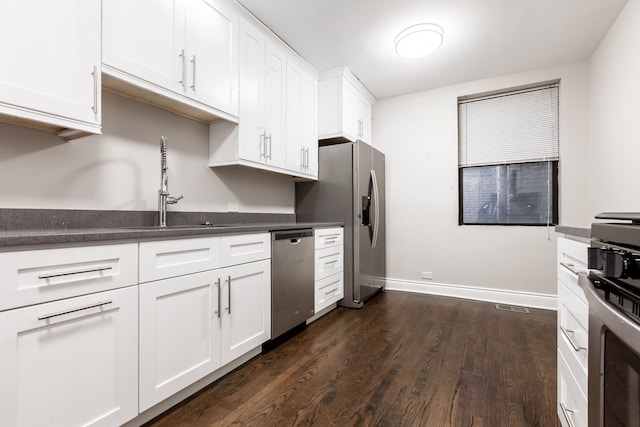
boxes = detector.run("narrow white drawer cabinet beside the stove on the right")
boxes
[558,237,589,427]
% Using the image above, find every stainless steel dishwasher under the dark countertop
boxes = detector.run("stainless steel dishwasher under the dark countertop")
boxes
[271,229,315,340]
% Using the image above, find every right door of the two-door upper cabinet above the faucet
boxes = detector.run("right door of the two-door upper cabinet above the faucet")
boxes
[186,0,238,116]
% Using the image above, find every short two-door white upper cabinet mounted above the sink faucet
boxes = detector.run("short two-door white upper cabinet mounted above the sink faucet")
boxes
[102,0,238,122]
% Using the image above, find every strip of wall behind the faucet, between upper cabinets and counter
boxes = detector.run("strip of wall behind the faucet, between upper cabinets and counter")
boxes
[0,92,294,213]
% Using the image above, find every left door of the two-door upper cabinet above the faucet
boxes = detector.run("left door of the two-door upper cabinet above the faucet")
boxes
[102,0,186,91]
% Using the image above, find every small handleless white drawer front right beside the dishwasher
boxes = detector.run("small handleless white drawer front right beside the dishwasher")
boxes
[220,233,271,267]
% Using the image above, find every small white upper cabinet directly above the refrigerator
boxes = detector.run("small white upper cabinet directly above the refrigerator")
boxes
[318,67,375,143]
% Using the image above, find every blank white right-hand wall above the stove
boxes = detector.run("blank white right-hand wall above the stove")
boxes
[588,1,640,217]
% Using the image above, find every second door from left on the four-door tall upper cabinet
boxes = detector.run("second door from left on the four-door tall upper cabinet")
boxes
[265,42,287,168]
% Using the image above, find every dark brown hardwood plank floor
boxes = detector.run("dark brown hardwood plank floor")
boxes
[148,291,560,427]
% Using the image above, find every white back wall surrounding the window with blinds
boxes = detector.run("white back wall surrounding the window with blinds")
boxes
[373,62,588,294]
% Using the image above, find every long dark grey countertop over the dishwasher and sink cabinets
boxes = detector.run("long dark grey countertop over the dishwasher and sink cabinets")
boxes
[0,222,344,247]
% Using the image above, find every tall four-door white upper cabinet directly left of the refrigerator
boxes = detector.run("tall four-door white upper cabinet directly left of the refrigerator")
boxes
[209,18,318,179]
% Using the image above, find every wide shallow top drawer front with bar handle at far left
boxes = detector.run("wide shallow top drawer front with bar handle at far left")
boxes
[0,243,138,310]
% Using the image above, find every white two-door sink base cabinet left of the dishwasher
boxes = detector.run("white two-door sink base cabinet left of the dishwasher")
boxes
[139,233,271,412]
